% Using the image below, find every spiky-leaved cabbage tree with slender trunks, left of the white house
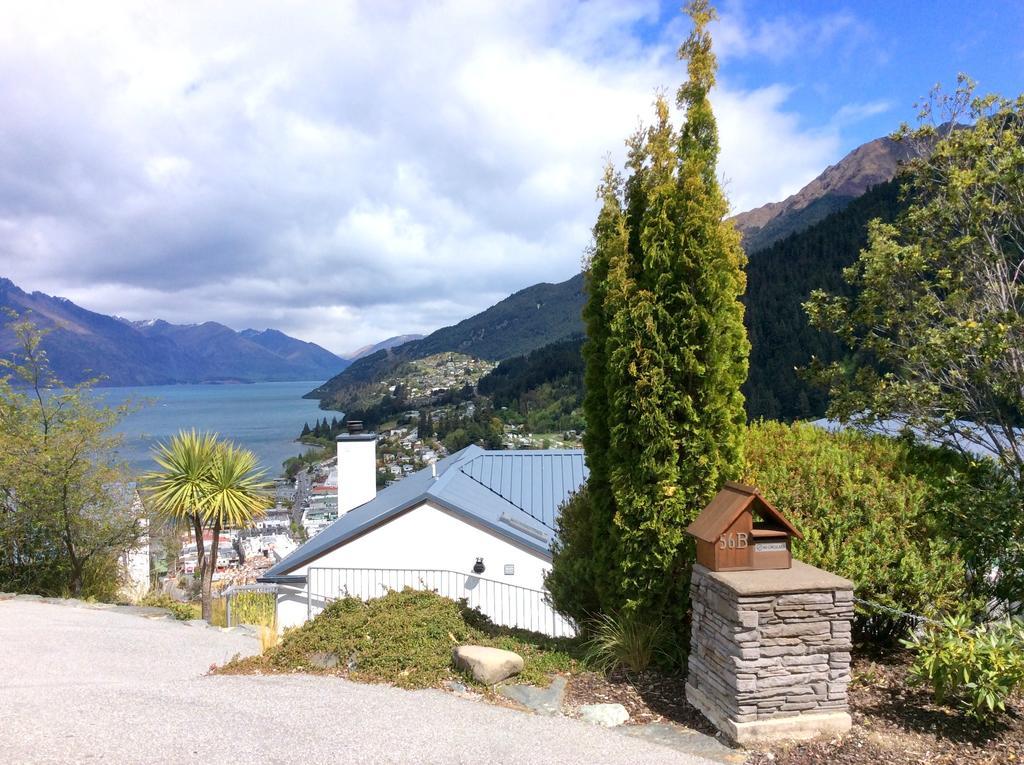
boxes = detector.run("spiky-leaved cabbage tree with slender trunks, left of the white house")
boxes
[145,430,270,622]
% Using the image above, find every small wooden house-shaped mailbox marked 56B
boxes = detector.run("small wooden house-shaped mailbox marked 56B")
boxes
[686,481,804,571]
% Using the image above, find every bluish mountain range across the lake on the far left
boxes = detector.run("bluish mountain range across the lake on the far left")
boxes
[0,279,349,385]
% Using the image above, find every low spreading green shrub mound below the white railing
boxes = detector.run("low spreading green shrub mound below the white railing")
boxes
[232,589,578,688]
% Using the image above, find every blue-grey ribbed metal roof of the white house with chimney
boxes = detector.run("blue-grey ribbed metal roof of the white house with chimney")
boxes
[260,445,588,581]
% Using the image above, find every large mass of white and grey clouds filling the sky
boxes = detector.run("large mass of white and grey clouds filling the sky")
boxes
[0,0,838,350]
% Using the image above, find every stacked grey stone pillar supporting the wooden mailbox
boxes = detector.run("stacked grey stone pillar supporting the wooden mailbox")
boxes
[687,565,853,728]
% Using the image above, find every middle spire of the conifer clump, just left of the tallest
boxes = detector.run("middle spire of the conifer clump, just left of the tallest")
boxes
[602,97,684,618]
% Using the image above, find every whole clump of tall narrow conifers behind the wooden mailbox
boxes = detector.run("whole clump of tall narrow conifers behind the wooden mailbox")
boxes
[553,0,750,642]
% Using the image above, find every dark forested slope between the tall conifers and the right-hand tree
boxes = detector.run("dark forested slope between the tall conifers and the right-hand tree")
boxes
[743,180,900,420]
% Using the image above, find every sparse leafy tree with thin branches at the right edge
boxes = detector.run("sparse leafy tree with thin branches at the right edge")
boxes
[807,82,1024,497]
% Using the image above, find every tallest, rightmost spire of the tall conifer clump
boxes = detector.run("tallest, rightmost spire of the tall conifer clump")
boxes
[673,0,751,499]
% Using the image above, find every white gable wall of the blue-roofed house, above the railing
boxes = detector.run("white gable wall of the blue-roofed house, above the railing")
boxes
[278,503,551,629]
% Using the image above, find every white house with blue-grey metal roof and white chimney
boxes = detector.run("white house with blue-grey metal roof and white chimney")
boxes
[260,433,588,635]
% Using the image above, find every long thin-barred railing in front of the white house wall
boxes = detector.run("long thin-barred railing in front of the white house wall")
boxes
[306,567,577,637]
